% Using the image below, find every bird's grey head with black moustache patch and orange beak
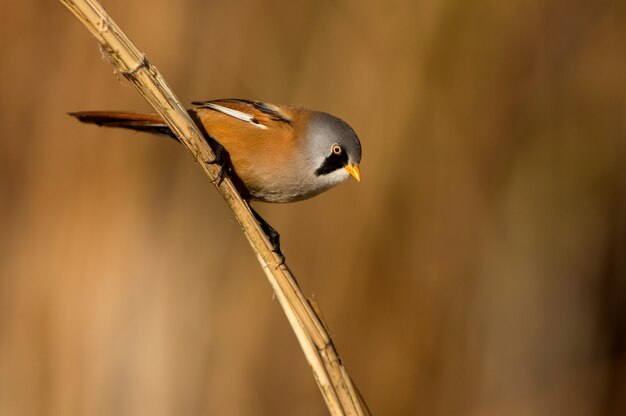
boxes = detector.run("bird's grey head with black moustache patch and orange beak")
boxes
[307,112,361,186]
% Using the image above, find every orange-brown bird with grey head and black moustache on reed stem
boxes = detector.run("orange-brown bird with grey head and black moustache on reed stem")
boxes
[69,99,361,259]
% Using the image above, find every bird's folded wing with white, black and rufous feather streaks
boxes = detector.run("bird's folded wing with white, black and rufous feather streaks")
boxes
[192,99,293,129]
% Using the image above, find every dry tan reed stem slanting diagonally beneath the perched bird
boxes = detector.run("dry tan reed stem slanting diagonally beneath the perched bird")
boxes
[61,0,369,415]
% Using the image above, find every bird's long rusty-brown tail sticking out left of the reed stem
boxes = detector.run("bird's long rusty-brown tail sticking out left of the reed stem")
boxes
[69,111,176,139]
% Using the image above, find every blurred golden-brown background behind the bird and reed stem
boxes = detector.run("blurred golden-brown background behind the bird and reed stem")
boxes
[0,0,626,416]
